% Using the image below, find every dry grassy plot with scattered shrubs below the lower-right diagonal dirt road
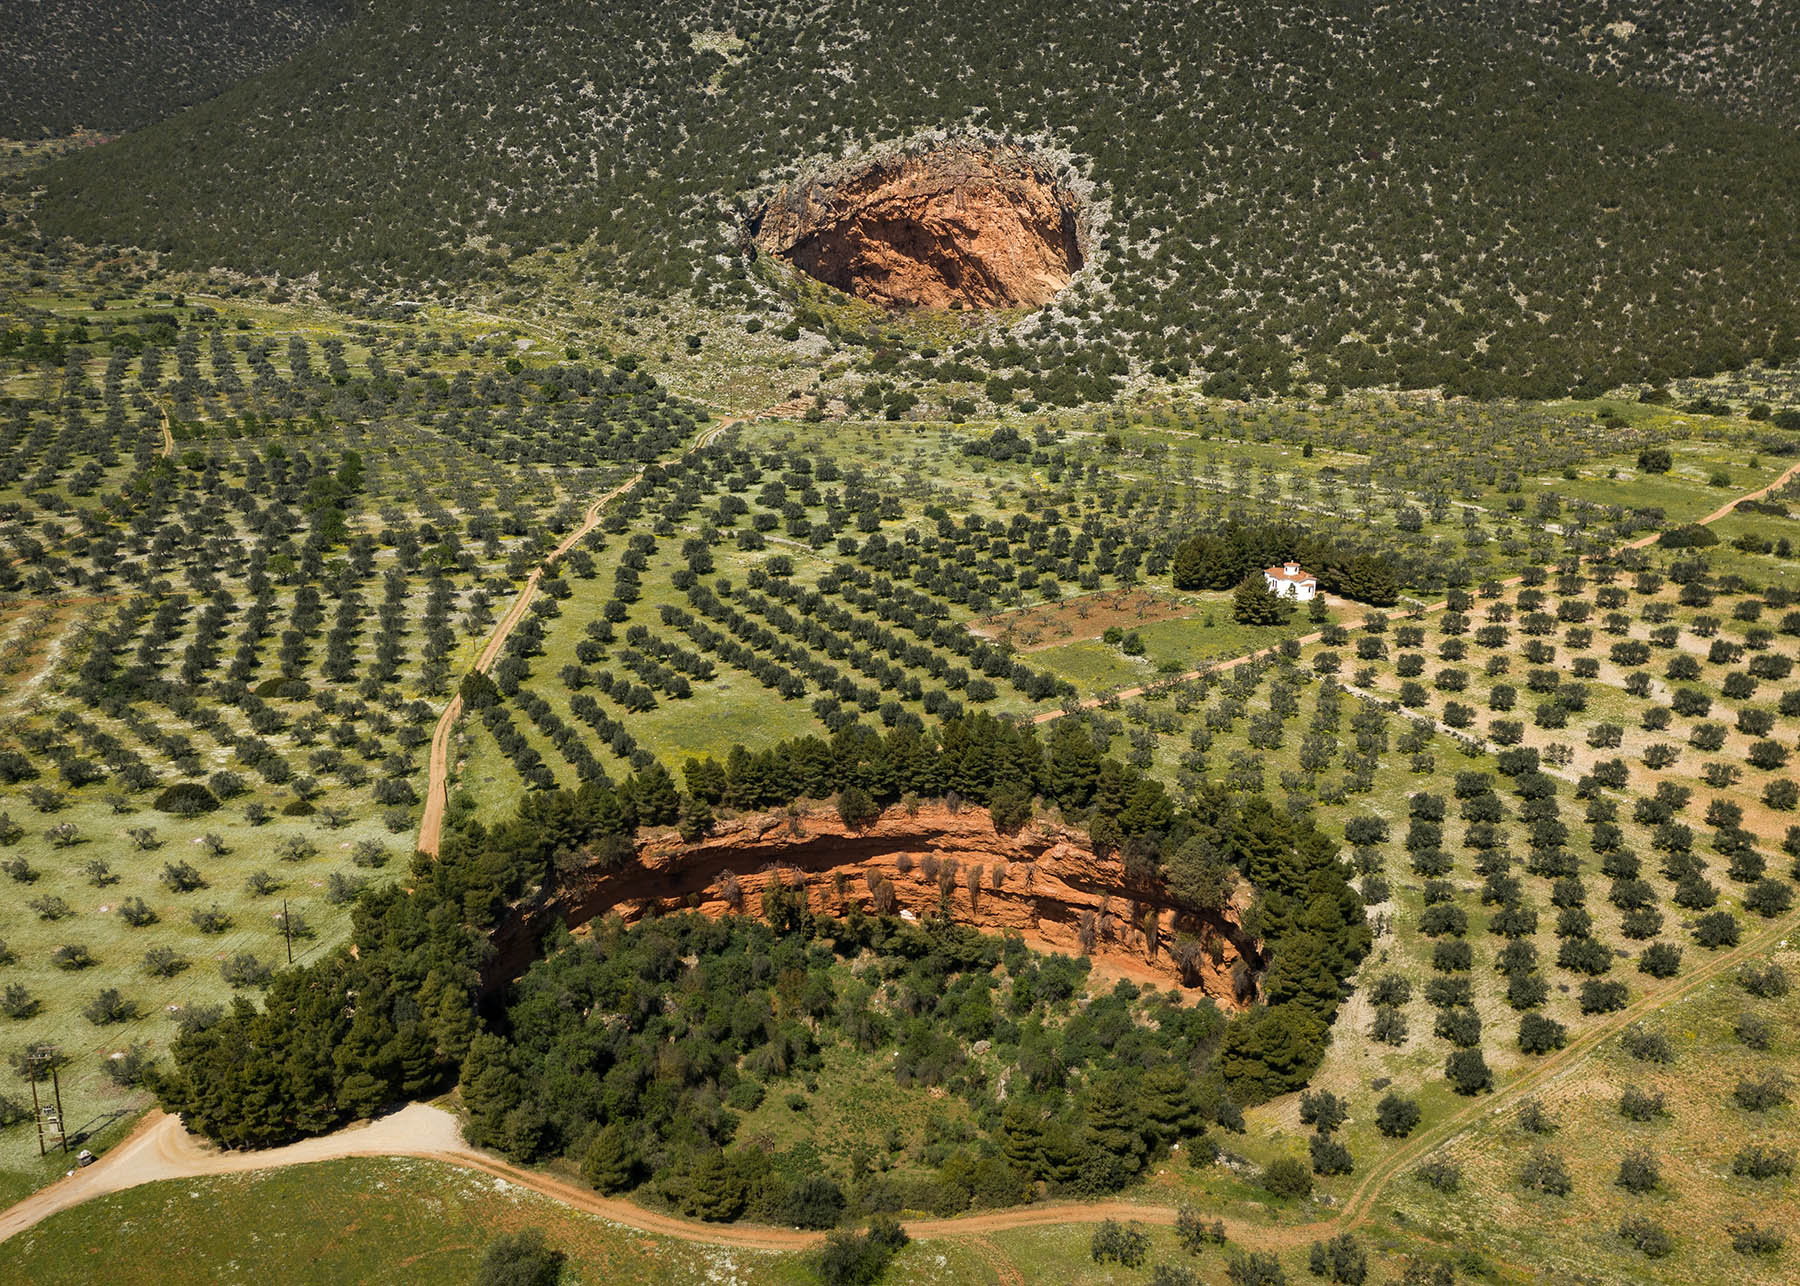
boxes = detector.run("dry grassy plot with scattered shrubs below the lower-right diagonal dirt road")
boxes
[1382,949,1800,1282]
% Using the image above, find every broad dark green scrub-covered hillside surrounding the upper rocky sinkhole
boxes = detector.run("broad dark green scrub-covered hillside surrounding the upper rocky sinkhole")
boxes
[38,0,1800,402]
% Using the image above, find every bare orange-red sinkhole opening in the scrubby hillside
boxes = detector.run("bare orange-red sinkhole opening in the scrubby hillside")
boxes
[751,144,1082,308]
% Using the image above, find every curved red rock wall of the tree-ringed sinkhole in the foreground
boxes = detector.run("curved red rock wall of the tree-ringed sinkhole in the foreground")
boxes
[488,807,1262,1009]
